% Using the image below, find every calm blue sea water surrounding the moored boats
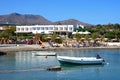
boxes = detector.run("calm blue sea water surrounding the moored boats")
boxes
[0,49,120,80]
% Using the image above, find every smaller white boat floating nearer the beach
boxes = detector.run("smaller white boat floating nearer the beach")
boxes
[33,51,56,56]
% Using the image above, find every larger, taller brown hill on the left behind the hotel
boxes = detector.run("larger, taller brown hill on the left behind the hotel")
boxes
[0,13,51,25]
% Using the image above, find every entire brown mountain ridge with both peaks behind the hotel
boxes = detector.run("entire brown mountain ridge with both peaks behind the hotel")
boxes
[0,13,91,26]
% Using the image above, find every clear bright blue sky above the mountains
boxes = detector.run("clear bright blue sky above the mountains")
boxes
[0,0,120,25]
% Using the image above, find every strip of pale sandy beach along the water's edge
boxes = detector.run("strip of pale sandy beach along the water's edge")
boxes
[0,44,120,53]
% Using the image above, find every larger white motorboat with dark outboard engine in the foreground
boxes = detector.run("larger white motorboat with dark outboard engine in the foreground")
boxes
[57,56,105,65]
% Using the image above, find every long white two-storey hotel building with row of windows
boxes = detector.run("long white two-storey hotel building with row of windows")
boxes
[16,25,74,34]
